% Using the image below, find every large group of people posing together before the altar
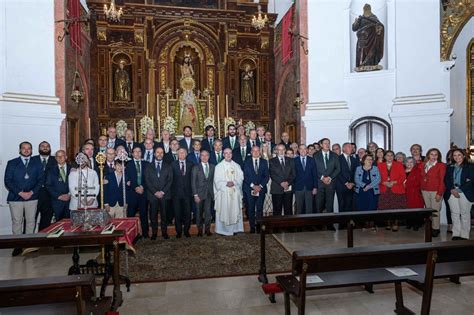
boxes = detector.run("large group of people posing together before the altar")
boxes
[5,125,474,254]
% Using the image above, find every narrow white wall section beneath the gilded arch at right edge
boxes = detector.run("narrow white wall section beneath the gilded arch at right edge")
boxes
[450,18,474,148]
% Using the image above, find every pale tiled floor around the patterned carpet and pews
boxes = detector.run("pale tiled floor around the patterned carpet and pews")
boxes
[0,228,474,315]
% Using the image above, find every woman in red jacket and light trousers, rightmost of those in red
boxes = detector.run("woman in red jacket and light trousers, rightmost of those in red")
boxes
[421,148,446,237]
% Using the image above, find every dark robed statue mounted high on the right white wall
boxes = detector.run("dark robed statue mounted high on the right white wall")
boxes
[352,4,384,71]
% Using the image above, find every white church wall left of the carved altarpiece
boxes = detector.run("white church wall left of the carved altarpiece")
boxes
[0,0,64,234]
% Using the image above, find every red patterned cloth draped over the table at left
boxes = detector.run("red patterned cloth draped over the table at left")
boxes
[40,217,142,252]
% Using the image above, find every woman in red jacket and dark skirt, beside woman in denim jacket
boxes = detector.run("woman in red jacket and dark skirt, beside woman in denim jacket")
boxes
[377,150,406,232]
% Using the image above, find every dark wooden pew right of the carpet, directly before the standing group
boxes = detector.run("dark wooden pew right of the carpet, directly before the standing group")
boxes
[257,208,433,286]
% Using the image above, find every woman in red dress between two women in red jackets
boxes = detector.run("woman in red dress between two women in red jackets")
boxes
[405,157,425,231]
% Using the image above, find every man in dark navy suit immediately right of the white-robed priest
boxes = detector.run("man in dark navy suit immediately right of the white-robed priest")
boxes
[246,146,269,233]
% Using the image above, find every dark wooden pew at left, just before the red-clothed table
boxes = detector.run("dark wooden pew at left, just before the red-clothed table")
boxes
[0,230,124,310]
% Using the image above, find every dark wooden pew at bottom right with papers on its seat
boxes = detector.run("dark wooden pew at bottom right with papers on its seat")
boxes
[276,241,474,315]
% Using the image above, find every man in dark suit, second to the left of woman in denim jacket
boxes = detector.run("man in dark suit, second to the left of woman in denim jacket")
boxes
[315,138,341,217]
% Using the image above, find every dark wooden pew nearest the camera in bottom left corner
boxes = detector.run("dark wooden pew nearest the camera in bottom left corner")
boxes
[0,274,112,315]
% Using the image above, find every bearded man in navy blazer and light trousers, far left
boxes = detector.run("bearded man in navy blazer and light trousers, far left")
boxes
[4,141,43,256]
